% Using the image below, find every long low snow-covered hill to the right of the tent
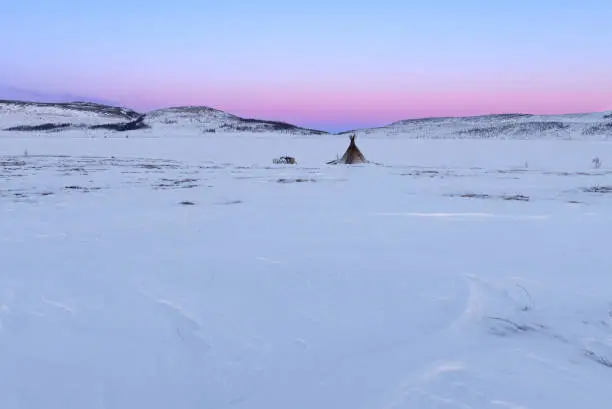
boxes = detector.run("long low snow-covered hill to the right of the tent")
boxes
[346,112,612,139]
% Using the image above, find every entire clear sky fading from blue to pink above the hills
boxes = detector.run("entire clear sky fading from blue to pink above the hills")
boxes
[0,0,612,130]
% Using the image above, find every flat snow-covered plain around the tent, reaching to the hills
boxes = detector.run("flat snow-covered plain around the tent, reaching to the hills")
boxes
[0,132,612,409]
